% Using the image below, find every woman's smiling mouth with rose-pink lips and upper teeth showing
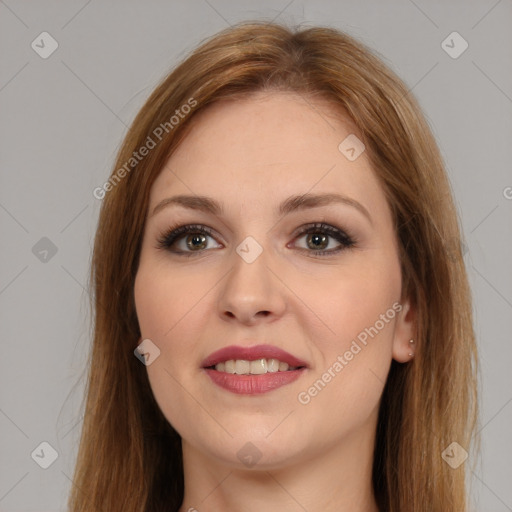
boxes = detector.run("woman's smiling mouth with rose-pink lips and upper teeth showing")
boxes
[202,345,307,395]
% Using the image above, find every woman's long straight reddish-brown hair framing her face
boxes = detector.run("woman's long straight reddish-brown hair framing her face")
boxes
[69,22,477,512]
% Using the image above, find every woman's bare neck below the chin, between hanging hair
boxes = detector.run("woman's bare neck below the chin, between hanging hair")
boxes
[179,410,378,512]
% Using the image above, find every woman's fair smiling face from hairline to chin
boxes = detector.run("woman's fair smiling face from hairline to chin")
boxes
[135,93,413,468]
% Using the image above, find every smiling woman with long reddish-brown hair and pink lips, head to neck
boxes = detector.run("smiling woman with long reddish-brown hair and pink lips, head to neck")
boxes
[69,23,477,512]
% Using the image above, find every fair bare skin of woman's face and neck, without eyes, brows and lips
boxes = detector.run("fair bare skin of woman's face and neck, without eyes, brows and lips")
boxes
[135,92,415,512]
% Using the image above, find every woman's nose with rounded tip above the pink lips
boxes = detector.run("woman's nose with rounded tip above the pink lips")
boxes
[218,245,288,325]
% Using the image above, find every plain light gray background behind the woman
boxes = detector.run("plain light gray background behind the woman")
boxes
[0,0,512,512]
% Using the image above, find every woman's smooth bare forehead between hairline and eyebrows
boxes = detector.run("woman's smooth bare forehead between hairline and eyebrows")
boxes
[150,92,385,222]
